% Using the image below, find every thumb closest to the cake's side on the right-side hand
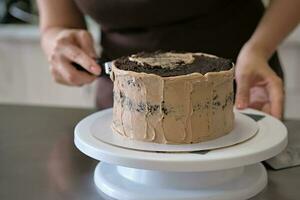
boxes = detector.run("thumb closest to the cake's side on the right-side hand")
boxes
[235,75,250,109]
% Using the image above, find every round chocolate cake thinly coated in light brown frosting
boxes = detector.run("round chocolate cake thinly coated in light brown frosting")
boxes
[111,52,234,144]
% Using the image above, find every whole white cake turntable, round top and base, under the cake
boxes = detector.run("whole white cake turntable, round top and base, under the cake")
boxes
[74,109,287,200]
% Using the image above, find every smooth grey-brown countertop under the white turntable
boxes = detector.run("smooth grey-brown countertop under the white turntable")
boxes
[0,104,300,200]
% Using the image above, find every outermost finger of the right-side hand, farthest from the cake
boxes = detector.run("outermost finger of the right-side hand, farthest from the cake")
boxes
[268,76,284,119]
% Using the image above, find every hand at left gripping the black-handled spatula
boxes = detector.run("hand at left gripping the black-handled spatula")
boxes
[42,28,101,86]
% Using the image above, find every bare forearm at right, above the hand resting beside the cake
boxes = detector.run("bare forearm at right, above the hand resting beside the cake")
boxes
[246,0,300,59]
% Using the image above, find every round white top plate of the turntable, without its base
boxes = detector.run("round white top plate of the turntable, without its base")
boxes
[75,109,287,172]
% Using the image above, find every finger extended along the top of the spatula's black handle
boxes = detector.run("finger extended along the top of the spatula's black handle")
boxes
[63,44,101,75]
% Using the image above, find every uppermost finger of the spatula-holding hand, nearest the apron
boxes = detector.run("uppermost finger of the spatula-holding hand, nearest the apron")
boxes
[76,31,97,58]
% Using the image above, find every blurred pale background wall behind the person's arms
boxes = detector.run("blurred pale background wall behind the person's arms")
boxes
[0,0,300,118]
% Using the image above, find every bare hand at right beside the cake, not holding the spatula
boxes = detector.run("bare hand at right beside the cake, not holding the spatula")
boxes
[235,44,284,119]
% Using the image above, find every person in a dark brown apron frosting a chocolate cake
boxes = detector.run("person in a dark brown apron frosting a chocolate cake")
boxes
[38,0,300,118]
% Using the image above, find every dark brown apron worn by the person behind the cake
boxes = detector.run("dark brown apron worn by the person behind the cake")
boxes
[75,0,283,109]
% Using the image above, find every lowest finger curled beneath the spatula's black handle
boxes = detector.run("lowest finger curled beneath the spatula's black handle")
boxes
[57,57,96,86]
